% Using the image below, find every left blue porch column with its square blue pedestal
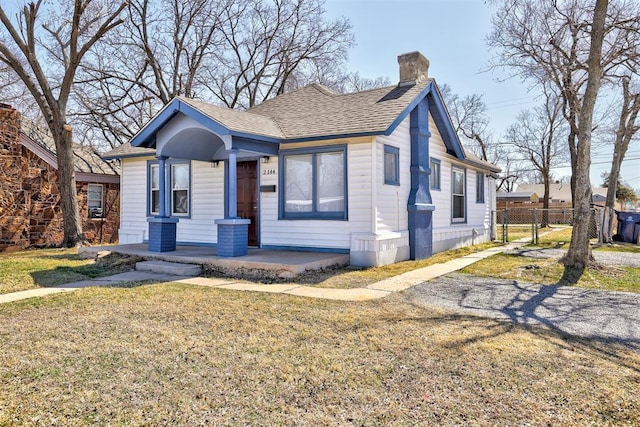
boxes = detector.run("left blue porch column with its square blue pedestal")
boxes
[147,156,178,252]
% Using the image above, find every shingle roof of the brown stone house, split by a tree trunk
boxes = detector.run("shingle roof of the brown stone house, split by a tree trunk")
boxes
[20,119,119,175]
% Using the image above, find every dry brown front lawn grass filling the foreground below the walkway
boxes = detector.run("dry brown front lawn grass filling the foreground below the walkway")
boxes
[0,284,640,426]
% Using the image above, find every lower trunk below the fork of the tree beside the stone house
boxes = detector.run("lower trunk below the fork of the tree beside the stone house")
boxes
[53,124,84,248]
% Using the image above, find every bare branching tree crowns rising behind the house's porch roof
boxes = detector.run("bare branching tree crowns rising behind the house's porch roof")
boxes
[80,0,353,146]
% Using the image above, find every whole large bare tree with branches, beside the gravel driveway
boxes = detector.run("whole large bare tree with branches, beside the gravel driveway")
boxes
[488,0,640,280]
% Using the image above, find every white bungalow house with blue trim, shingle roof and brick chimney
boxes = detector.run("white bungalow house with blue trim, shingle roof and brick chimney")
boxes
[104,52,499,266]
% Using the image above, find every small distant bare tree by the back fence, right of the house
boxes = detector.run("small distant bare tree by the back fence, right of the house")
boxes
[506,86,568,227]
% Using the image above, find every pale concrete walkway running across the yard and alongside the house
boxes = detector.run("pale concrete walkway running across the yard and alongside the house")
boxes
[0,243,518,304]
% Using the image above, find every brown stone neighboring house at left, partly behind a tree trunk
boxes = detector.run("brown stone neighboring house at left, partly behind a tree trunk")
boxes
[0,104,120,251]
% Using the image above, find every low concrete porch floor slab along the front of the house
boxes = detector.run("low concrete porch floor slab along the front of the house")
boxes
[78,243,349,278]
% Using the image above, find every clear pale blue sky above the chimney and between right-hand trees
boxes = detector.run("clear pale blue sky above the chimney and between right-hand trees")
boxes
[325,0,640,191]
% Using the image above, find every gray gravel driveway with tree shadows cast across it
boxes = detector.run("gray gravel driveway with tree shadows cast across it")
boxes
[404,250,640,350]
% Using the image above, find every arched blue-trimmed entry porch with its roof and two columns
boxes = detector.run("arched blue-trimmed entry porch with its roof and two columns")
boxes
[131,98,280,258]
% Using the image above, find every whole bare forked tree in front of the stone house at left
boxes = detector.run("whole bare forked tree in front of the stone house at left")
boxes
[0,0,126,246]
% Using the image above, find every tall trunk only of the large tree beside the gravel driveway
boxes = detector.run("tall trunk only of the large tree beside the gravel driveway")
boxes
[562,0,609,283]
